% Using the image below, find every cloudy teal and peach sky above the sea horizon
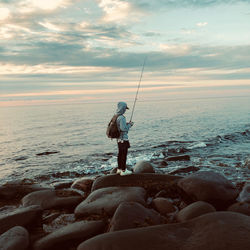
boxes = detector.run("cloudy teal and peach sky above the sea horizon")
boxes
[0,0,250,106]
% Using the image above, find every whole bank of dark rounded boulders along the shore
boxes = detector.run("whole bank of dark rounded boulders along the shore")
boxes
[0,159,250,250]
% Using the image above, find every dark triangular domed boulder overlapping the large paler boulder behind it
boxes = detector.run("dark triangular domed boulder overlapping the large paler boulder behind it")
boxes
[109,202,165,232]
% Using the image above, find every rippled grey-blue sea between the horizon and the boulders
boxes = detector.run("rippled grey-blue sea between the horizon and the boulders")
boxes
[0,97,250,183]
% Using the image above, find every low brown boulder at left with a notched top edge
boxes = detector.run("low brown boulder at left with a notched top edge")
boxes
[22,190,82,209]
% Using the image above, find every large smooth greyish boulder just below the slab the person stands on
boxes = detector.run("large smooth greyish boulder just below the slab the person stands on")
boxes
[75,187,146,217]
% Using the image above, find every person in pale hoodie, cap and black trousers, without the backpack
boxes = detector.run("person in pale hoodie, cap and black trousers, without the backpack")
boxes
[116,102,134,175]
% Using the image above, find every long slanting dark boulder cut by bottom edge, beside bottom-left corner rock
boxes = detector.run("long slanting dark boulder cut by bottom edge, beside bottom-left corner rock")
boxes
[33,221,106,250]
